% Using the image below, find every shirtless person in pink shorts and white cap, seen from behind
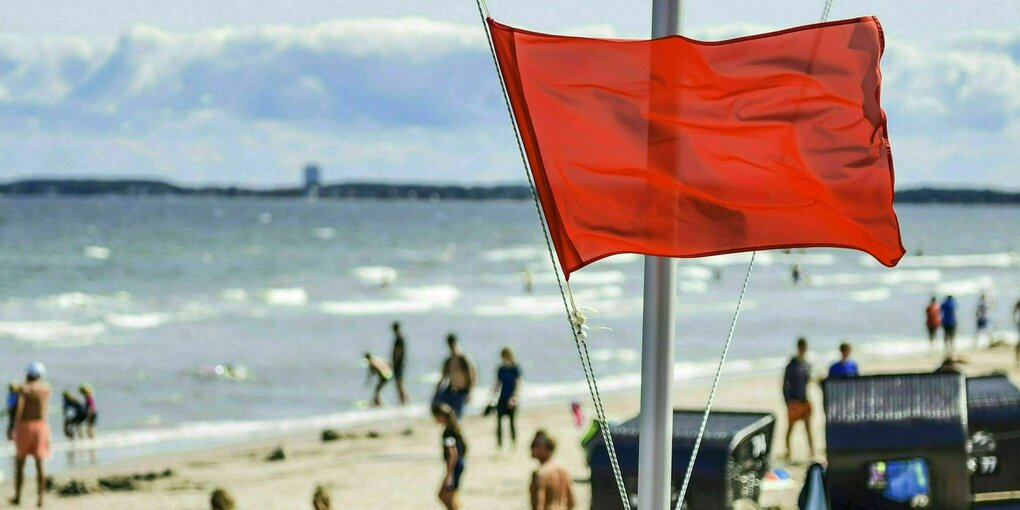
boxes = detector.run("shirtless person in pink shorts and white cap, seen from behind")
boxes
[10,361,50,507]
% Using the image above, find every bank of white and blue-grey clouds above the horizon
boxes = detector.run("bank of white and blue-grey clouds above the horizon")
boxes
[0,17,1020,188]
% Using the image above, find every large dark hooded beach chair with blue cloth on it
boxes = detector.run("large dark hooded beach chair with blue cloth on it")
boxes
[822,373,971,510]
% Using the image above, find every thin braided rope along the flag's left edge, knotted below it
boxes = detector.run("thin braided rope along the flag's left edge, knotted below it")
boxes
[475,0,630,510]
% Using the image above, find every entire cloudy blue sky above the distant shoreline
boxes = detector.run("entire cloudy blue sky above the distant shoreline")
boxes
[0,0,1020,191]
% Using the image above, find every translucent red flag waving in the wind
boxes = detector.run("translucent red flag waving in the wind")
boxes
[489,17,904,277]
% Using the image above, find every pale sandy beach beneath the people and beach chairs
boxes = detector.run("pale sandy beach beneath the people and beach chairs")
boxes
[3,347,1020,510]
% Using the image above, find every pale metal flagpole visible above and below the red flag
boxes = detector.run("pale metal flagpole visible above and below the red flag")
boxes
[638,0,682,510]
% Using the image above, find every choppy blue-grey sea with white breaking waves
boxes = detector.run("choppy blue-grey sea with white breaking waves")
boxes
[0,197,1020,475]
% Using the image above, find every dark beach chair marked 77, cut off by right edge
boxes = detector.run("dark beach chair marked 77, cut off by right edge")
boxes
[967,374,1020,509]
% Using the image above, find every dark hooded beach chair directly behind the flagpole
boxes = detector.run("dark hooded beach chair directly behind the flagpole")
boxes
[587,410,775,510]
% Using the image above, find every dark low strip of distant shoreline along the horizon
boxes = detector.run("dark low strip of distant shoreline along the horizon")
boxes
[0,179,1020,205]
